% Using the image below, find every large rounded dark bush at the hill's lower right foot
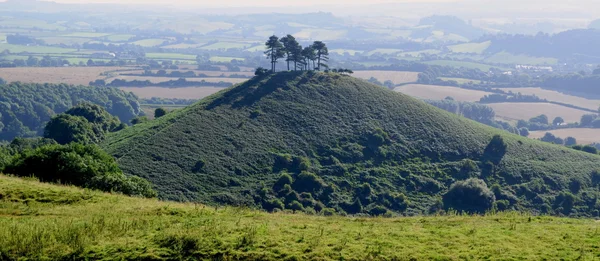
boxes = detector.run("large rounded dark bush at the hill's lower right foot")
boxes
[443,179,496,213]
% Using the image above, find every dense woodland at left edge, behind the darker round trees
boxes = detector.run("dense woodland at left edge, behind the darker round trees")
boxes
[0,82,141,141]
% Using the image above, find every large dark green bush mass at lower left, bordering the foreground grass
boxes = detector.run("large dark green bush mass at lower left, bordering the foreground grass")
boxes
[4,143,156,197]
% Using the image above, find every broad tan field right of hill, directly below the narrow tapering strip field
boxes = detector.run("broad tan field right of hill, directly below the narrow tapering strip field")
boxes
[486,102,589,123]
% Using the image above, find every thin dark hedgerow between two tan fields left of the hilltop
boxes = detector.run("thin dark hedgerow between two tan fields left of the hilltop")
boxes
[90,78,233,88]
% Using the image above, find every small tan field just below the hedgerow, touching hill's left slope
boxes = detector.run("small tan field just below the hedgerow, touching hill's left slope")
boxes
[119,87,225,99]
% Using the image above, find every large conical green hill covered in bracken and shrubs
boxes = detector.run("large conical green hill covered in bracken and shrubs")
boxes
[103,72,600,215]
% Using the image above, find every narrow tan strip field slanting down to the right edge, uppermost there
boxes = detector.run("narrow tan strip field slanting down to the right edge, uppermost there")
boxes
[501,87,600,110]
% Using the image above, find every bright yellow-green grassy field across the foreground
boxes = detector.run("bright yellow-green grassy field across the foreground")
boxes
[0,176,600,260]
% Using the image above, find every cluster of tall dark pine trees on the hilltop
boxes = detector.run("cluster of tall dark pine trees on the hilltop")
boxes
[265,34,329,72]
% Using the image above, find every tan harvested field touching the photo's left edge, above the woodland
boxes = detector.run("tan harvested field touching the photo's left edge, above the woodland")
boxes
[0,67,135,85]
